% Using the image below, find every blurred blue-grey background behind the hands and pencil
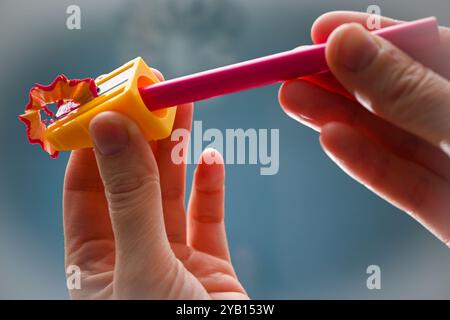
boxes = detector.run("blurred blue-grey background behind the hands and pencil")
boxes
[0,0,450,299]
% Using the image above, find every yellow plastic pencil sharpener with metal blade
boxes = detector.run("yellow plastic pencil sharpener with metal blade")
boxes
[44,57,176,150]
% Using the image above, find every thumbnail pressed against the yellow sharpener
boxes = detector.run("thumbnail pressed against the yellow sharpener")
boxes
[89,113,129,156]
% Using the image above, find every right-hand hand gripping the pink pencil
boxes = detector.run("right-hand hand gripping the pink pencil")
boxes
[279,12,450,245]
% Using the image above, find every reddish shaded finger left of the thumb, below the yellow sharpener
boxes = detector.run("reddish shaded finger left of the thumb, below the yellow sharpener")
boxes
[63,149,114,271]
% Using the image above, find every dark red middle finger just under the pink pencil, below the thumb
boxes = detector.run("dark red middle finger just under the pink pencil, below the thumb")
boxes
[279,80,450,181]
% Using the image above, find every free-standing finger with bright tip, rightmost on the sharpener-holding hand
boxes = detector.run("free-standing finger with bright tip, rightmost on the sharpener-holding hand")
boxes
[188,149,230,261]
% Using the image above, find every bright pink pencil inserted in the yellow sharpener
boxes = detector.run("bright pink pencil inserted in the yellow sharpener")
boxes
[140,17,439,111]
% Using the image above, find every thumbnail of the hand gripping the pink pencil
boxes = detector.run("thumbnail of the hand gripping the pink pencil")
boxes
[337,25,379,72]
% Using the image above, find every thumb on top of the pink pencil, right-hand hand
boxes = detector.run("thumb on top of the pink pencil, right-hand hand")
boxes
[326,24,450,149]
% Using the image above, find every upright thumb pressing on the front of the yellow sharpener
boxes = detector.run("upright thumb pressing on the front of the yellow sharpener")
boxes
[89,112,176,296]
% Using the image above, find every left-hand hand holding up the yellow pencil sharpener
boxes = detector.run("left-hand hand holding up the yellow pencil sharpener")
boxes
[64,70,248,299]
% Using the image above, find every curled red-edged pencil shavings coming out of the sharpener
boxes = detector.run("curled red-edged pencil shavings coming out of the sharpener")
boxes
[19,75,98,158]
